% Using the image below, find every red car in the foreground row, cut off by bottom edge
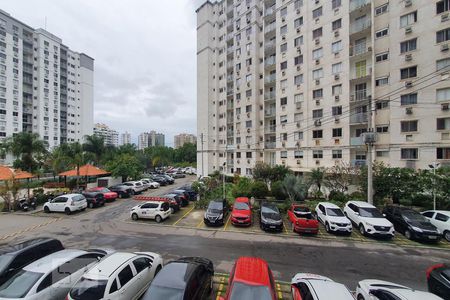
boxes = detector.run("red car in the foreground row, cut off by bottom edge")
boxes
[219,257,277,300]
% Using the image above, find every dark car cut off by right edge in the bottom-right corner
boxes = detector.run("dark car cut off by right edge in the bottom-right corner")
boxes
[427,264,450,300]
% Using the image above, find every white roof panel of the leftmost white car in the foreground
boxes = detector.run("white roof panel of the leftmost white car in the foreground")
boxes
[23,249,88,273]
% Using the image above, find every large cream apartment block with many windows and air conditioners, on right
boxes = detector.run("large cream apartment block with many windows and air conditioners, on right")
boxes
[197,0,450,175]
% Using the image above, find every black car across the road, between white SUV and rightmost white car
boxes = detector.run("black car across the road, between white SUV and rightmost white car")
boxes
[383,205,441,242]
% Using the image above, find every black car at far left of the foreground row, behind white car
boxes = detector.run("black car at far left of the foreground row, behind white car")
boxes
[0,238,64,285]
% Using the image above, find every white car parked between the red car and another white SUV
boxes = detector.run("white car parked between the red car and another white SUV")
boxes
[316,202,352,234]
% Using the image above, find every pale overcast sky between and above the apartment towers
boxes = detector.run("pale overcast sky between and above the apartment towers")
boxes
[0,0,204,146]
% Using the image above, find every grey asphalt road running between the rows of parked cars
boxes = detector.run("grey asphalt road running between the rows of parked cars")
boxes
[0,178,450,290]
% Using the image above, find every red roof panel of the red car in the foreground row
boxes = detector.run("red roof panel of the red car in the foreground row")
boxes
[234,257,270,286]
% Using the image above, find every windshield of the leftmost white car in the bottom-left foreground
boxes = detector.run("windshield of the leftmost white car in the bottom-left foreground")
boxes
[0,270,44,298]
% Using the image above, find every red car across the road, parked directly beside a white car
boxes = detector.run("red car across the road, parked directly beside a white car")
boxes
[288,204,319,234]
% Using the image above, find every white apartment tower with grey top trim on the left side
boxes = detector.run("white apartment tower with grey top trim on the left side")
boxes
[0,10,94,147]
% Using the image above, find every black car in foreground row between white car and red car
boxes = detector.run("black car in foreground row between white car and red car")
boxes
[142,257,214,300]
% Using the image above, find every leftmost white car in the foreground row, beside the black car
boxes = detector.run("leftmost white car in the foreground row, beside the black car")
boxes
[0,249,106,300]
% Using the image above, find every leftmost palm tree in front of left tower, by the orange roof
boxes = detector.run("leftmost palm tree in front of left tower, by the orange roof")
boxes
[4,132,47,173]
